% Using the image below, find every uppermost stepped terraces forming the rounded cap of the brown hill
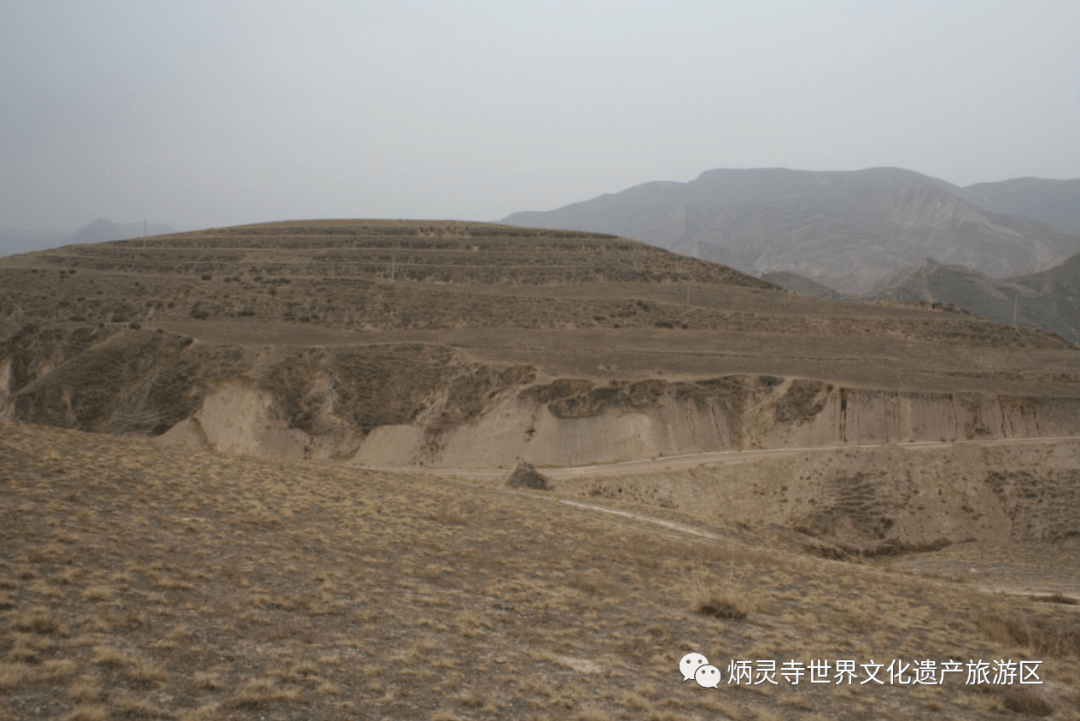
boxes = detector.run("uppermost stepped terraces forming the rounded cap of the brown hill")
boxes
[4,220,769,287]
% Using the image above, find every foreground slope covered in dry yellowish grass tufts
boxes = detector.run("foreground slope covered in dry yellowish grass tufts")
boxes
[0,421,1080,721]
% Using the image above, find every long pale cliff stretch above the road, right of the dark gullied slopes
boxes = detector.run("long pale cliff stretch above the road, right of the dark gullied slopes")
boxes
[354,376,1080,467]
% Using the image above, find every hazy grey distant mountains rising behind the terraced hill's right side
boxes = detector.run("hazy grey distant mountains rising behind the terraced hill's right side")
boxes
[502,167,1080,294]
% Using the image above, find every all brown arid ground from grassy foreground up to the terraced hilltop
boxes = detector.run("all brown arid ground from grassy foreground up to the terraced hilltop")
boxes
[0,220,1080,721]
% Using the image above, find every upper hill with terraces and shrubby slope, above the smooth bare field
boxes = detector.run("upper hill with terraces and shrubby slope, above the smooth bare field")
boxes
[0,220,1059,348]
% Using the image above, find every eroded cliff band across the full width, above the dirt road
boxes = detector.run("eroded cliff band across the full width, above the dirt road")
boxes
[0,327,1080,467]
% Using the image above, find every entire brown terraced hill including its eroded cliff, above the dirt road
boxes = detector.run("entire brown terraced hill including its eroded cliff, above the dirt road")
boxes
[0,220,1080,543]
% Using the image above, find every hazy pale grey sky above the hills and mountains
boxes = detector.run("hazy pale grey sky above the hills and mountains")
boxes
[0,0,1080,230]
